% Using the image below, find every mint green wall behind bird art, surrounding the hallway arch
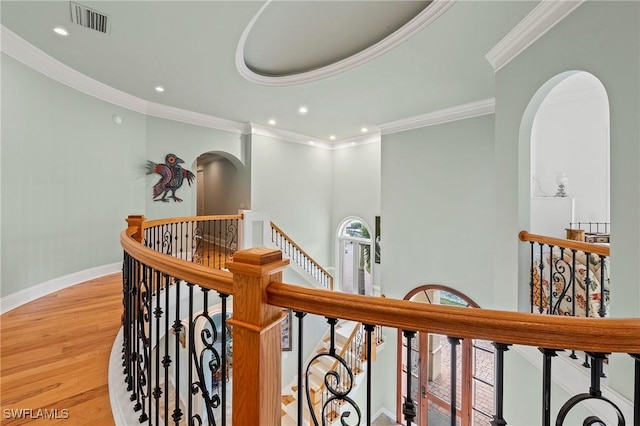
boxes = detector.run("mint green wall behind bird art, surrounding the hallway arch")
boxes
[141,116,248,219]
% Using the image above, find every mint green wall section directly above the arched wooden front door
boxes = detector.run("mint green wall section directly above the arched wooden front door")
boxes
[381,115,495,307]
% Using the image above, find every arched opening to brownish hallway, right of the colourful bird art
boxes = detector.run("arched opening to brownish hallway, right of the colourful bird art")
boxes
[193,151,251,216]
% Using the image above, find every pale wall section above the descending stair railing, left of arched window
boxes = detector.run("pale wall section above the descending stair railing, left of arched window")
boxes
[251,134,333,265]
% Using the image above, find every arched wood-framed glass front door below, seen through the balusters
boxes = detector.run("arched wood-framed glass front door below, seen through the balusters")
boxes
[396,285,494,426]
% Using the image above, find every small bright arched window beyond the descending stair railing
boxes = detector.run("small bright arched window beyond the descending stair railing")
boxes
[337,217,373,295]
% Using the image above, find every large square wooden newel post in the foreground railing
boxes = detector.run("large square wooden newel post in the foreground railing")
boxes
[227,248,289,426]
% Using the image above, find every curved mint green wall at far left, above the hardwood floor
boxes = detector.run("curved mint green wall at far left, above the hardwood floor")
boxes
[1,55,146,297]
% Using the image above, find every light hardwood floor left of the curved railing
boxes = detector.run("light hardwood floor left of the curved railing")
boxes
[0,273,122,426]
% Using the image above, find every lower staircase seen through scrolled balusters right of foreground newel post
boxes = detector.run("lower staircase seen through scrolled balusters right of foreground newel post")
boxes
[281,320,384,426]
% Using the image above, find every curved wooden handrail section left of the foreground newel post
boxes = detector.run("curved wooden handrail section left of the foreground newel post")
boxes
[120,228,233,294]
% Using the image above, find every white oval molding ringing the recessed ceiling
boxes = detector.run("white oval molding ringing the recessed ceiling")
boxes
[236,0,455,86]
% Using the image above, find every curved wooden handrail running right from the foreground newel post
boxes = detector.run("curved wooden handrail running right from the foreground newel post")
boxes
[267,282,640,353]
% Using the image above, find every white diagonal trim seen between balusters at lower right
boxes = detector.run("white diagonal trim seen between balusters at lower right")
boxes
[513,345,633,425]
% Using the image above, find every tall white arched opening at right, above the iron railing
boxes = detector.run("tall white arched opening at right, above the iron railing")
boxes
[527,71,610,238]
